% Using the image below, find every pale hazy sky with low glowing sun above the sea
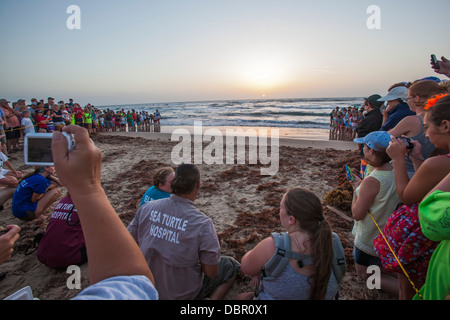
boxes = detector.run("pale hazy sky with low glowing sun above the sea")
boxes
[0,0,450,105]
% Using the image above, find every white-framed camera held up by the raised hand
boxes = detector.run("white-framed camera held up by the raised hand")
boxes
[23,132,75,166]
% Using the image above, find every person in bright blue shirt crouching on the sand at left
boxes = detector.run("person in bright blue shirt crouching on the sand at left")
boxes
[12,166,62,221]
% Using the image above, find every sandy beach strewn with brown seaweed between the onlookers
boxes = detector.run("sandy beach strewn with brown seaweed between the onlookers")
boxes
[0,127,395,300]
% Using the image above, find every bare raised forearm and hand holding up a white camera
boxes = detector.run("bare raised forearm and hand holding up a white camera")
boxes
[52,125,154,284]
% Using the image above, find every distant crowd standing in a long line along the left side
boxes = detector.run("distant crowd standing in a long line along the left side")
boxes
[0,97,161,150]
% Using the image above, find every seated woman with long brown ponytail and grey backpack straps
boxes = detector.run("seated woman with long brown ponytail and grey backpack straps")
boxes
[236,187,339,300]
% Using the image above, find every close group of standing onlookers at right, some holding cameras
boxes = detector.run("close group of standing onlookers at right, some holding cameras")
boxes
[352,57,450,300]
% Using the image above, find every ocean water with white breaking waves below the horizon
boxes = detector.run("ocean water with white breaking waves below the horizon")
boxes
[98,97,363,129]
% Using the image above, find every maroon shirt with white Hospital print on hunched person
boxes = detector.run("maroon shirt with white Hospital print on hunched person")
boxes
[37,194,87,269]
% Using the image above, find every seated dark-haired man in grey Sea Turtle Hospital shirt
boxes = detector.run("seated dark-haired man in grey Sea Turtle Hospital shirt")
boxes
[128,164,239,300]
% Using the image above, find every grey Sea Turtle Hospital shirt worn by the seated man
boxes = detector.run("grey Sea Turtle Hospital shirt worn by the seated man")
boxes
[128,194,220,300]
